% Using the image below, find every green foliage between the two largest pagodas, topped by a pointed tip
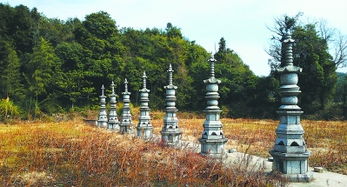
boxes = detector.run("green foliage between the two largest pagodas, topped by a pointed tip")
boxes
[215,38,258,117]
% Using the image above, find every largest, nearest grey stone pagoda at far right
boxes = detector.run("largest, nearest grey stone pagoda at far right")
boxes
[270,33,312,182]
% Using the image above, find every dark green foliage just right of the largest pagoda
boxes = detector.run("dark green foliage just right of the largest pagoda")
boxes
[293,24,337,113]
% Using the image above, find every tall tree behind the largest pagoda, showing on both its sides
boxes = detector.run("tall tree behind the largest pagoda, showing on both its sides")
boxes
[269,16,336,114]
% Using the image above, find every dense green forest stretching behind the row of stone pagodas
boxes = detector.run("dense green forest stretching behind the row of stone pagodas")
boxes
[0,4,347,120]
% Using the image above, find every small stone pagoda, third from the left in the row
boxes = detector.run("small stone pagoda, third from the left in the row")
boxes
[119,79,133,134]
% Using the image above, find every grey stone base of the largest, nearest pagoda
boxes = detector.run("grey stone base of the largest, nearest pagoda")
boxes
[270,150,313,182]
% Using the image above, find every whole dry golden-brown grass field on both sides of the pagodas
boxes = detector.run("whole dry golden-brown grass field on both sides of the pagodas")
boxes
[0,112,347,186]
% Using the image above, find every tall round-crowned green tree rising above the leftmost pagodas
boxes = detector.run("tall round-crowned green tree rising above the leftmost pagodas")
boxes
[74,12,125,103]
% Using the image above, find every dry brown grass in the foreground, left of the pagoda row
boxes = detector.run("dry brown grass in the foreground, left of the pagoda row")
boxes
[0,120,281,186]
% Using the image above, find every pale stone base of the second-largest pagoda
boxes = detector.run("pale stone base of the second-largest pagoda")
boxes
[199,138,228,158]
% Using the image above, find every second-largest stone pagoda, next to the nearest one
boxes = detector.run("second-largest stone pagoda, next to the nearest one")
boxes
[199,57,227,158]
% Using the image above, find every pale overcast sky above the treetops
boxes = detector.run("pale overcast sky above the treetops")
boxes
[0,0,347,75]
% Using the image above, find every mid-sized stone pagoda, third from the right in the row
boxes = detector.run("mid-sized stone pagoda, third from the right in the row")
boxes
[160,64,182,145]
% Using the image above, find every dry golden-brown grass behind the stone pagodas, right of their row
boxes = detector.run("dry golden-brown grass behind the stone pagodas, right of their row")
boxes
[153,116,347,174]
